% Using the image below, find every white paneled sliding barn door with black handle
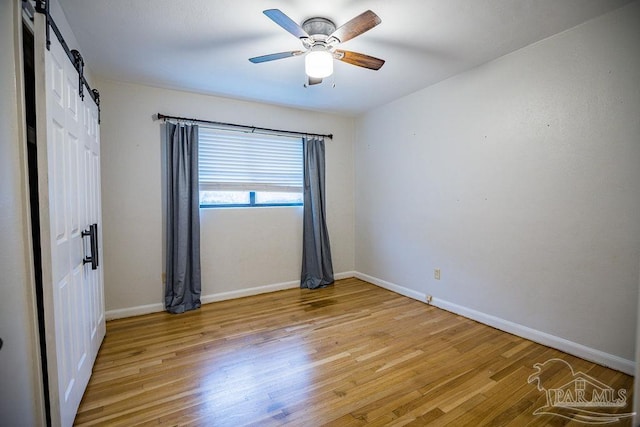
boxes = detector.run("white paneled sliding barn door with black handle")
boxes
[36,17,105,426]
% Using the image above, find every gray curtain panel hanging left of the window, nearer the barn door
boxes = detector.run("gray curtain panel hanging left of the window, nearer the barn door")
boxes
[164,123,201,313]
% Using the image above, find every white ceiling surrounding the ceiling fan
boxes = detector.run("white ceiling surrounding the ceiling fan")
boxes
[59,0,631,115]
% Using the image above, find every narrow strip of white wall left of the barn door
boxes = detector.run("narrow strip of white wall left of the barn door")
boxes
[0,1,44,426]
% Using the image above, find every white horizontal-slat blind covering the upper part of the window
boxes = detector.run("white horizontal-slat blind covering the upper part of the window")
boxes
[198,127,303,192]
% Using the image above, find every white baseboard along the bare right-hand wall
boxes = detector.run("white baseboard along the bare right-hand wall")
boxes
[355,272,636,375]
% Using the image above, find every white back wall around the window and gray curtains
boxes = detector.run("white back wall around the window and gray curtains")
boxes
[96,79,354,317]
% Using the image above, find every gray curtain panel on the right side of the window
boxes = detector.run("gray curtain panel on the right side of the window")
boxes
[300,138,333,289]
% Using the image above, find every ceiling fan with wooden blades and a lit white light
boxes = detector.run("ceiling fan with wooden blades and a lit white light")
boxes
[249,9,384,85]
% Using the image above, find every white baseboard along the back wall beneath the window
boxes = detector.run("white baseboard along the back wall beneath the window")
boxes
[105,271,356,320]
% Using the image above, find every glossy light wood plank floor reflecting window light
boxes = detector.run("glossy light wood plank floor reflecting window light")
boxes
[76,279,633,427]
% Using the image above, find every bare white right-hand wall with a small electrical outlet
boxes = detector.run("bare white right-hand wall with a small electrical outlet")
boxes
[355,2,640,372]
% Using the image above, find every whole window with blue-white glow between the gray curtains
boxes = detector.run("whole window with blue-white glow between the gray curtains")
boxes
[198,127,303,207]
